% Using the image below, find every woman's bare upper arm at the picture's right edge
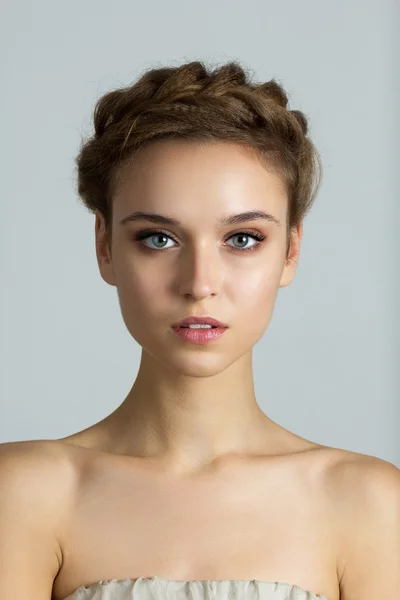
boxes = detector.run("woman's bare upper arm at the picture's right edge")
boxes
[340,458,400,600]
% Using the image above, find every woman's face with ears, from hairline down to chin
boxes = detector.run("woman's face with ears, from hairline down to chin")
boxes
[96,140,302,376]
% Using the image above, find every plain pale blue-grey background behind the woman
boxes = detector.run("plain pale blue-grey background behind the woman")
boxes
[0,0,400,466]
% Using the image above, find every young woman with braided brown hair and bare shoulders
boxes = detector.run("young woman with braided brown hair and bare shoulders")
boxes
[0,62,400,600]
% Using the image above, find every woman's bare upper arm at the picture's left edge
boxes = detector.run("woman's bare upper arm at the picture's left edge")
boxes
[0,442,70,600]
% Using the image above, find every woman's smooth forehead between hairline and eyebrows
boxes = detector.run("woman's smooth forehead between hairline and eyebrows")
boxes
[113,139,287,220]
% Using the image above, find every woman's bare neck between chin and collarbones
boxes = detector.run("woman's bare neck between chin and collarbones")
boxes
[99,351,282,471]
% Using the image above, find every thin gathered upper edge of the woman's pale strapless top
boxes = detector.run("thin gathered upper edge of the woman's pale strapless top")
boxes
[63,575,328,600]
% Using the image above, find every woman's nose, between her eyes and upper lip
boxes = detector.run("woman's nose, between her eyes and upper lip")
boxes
[177,242,223,300]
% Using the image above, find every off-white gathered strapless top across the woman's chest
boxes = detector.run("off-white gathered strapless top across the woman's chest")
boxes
[60,576,328,600]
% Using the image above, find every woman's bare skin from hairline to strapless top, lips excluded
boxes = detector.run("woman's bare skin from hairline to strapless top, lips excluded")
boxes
[0,140,400,600]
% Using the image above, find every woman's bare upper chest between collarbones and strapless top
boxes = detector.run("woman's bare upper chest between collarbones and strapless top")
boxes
[55,458,336,599]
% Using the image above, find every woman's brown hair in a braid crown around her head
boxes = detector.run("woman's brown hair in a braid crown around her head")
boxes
[75,61,322,254]
